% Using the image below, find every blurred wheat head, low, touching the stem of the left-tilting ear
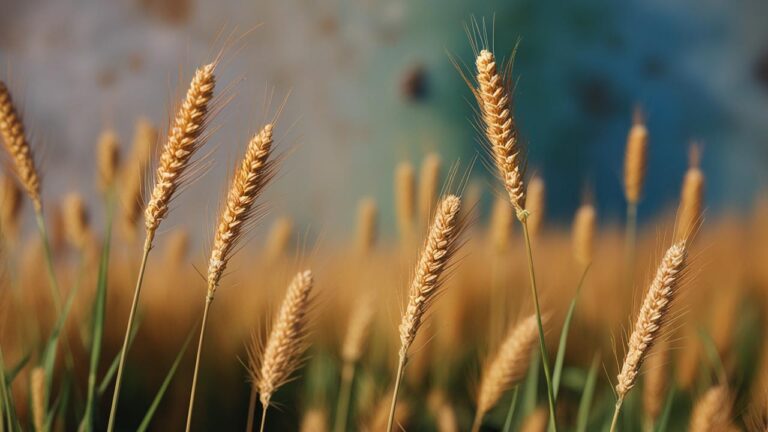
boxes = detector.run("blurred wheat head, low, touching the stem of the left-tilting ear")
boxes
[475,315,539,426]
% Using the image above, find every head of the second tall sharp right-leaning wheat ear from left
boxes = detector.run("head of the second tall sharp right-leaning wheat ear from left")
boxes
[208,124,274,297]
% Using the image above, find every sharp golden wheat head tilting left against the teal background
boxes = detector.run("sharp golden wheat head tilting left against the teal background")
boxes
[475,50,525,214]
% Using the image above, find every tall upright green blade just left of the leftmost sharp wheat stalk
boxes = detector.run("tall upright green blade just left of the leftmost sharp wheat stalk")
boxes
[80,200,113,432]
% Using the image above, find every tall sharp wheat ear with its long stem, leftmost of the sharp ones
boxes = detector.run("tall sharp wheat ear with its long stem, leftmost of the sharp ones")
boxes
[107,62,216,432]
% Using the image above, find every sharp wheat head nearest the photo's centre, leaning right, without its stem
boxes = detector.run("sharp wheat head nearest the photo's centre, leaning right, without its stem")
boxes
[400,195,462,359]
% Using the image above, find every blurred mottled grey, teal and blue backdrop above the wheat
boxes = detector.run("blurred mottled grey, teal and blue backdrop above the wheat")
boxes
[0,0,768,240]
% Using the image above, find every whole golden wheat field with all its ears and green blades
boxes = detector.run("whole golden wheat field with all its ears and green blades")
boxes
[0,27,768,431]
